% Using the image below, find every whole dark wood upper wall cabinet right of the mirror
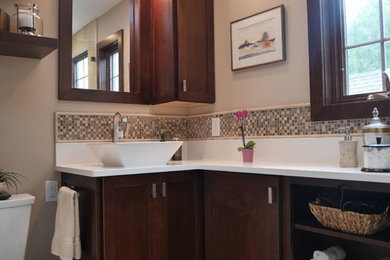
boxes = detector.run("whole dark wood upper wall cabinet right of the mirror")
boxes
[151,0,215,104]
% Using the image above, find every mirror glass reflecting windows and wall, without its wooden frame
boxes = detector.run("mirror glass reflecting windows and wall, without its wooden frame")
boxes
[72,0,130,92]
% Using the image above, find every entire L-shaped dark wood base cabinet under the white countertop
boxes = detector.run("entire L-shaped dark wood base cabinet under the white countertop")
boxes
[62,170,390,260]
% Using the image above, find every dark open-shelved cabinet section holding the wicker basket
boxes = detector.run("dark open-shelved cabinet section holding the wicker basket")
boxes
[283,177,390,260]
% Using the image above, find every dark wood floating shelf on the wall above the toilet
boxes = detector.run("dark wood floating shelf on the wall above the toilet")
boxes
[0,31,58,59]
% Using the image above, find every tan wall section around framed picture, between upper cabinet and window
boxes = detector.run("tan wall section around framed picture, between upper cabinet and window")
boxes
[189,0,309,114]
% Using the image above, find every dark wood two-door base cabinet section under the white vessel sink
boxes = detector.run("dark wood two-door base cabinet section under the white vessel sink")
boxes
[62,171,204,260]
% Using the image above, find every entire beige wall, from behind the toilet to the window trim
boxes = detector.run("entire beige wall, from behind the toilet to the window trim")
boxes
[0,0,309,260]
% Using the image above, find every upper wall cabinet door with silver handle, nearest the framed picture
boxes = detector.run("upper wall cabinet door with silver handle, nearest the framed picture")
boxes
[177,0,215,103]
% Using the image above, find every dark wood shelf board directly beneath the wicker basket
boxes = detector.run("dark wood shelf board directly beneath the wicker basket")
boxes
[293,223,390,249]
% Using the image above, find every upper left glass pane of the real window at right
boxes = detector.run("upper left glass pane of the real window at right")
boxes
[344,0,380,46]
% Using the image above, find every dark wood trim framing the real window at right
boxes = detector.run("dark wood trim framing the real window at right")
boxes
[307,0,390,121]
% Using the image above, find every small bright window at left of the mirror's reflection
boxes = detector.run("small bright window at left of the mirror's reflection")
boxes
[73,52,88,89]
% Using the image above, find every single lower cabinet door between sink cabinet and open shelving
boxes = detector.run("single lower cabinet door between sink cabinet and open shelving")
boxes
[205,173,280,260]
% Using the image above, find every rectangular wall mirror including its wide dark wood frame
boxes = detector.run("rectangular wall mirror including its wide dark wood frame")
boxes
[58,0,151,104]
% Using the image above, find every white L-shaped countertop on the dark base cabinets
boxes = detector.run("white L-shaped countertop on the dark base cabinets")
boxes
[56,160,390,183]
